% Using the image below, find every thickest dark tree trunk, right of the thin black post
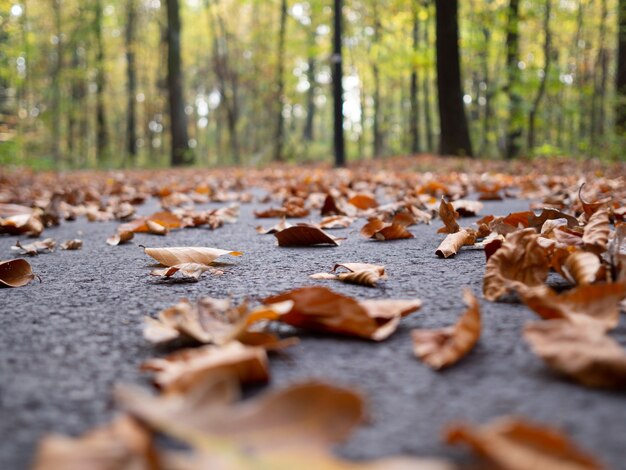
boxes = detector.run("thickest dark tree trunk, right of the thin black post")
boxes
[435,0,473,156]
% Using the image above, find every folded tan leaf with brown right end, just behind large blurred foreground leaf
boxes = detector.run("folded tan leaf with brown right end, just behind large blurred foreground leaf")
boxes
[141,341,269,393]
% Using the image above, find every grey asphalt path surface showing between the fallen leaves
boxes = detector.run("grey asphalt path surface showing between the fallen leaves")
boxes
[0,195,626,470]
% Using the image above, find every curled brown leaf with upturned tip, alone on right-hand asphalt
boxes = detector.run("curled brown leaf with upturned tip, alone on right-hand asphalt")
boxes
[411,289,481,370]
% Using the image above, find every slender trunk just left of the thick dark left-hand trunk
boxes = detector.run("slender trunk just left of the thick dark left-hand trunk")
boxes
[126,0,137,166]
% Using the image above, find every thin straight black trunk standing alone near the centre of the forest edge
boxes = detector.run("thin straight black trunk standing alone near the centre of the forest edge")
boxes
[332,0,346,167]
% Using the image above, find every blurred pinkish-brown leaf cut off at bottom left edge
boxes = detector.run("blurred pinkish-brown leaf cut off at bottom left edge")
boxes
[33,416,161,470]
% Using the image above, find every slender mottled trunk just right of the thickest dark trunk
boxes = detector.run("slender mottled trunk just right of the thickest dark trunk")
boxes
[505,0,524,159]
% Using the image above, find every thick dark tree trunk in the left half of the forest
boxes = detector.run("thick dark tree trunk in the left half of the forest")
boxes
[167,0,194,166]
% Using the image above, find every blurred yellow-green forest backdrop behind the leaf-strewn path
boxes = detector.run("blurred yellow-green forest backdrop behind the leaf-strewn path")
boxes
[0,0,626,168]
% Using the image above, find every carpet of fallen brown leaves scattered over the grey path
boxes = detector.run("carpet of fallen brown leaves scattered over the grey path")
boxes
[0,156,626,469]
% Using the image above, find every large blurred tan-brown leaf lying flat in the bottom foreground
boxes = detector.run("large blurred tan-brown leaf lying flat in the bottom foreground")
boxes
[116,381,365,452]
